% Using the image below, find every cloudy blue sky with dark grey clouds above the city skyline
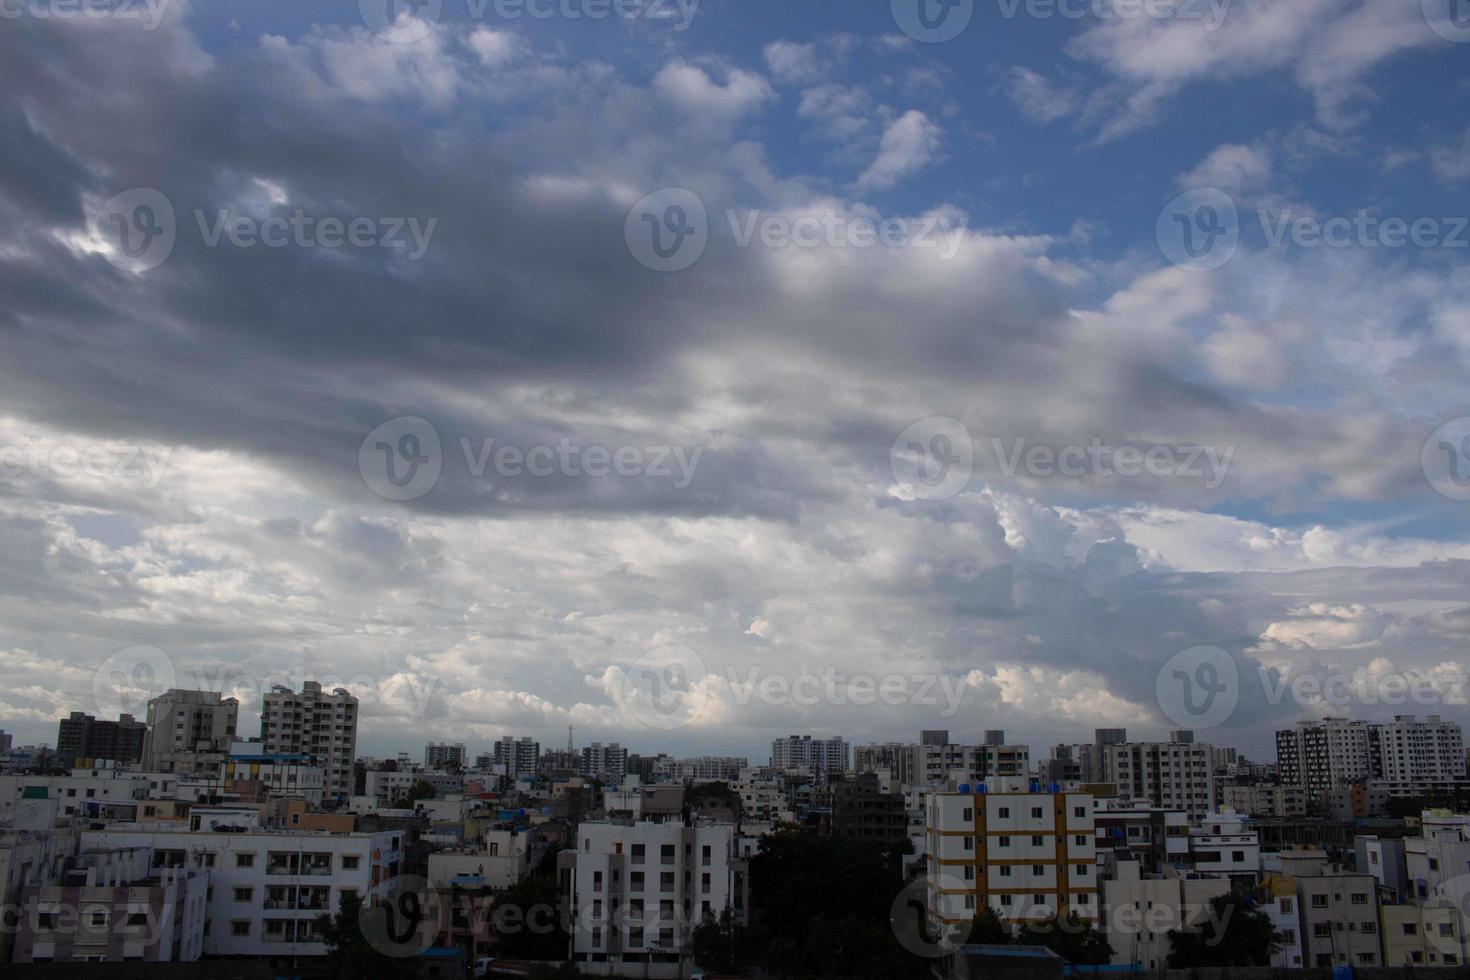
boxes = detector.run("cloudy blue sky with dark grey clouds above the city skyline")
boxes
[0,0,1470,760]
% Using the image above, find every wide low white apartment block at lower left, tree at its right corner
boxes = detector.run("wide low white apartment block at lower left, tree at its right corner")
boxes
[82,811,403,956]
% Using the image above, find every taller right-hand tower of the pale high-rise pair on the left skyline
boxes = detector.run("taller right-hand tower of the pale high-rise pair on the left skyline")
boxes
[260,680,357,804]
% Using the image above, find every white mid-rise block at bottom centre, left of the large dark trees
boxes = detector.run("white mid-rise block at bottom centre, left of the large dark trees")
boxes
[557,823,748,980]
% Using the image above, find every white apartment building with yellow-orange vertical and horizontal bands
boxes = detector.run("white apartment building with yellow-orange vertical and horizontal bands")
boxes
[926,786,1098,926]
